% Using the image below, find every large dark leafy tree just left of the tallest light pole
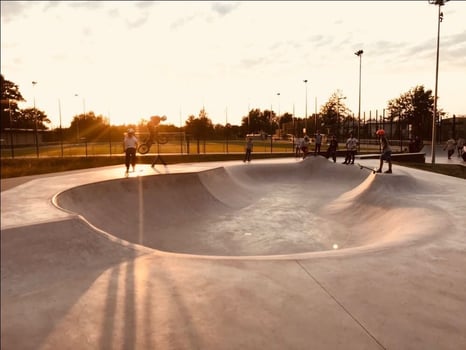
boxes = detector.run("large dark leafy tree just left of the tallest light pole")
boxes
[387,85,436,139]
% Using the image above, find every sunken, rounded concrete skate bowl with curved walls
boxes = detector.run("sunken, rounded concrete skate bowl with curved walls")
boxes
[54,157,448,257]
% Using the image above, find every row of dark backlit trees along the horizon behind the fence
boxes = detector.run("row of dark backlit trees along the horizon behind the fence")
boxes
[1,75,445,141]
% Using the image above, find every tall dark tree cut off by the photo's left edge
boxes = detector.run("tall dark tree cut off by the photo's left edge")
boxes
[0,75,25,130]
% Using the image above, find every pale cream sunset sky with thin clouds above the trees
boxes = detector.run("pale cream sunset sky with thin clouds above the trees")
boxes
[1,0,466,128]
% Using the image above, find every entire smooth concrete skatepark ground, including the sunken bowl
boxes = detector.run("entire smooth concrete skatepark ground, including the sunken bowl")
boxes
[1,155,466,350]
